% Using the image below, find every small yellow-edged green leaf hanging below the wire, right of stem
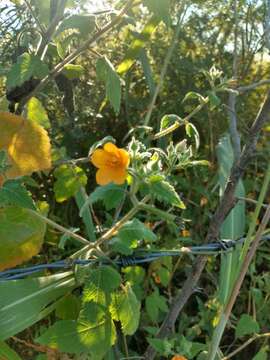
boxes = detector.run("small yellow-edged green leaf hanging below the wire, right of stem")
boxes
[110,284,140,335]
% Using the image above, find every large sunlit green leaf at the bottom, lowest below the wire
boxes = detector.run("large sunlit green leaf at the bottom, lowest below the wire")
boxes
[36,302,116,359]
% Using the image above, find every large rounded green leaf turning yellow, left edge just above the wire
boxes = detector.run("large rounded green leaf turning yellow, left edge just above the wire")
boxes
[0,206,46,271]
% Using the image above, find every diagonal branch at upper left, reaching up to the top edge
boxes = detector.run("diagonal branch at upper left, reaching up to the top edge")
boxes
[18,0,134,112]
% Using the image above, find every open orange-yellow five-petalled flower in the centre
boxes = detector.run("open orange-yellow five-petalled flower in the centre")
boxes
[91,142,129,185]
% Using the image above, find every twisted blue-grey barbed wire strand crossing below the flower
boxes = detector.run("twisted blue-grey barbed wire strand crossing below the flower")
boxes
[0,235,270,282]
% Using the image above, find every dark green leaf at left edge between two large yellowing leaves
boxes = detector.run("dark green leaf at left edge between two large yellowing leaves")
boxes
[0,180,35,210]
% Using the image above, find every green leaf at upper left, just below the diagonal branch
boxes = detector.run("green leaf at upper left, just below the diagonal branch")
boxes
[6,53,49,90]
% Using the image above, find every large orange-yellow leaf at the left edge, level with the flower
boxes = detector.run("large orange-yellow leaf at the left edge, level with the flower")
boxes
[0,112,51,179]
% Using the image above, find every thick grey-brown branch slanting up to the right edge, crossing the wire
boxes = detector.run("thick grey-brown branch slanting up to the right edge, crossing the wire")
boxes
[144,92,270,360]
